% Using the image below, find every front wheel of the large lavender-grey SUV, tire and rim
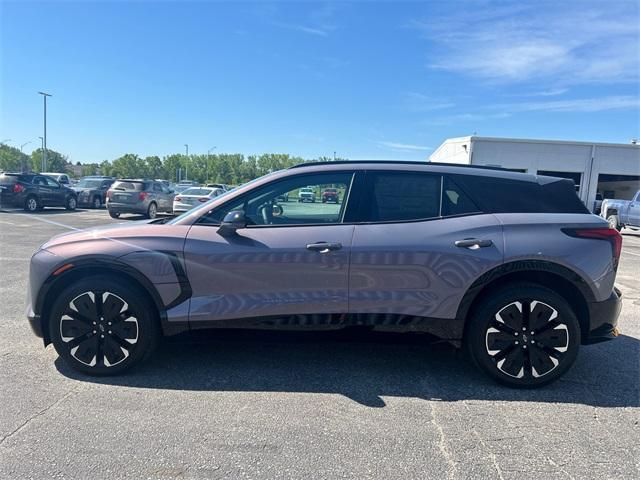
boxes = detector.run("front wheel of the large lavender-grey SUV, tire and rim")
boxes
[49,276,160,375]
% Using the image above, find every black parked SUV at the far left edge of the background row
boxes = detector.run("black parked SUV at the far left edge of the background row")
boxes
[0,173,77,212]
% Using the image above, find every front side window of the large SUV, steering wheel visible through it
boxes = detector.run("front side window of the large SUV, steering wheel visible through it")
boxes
[198,172,353,226]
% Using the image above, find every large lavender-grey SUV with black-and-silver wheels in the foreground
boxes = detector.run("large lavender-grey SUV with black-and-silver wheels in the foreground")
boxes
[28,162,621,387]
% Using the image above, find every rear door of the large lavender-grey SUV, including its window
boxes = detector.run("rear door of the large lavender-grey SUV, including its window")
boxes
[349,172,503,318]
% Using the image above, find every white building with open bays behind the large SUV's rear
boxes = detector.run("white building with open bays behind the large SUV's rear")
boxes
[429,136,640,209]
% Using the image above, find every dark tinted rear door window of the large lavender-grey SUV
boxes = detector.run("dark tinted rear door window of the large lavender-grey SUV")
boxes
[364,172,441,222]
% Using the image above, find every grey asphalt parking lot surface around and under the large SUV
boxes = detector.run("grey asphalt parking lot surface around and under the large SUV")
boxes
[0,209,640,479]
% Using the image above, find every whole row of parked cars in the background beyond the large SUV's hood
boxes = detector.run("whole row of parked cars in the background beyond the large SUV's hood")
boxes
[0,173,229,218]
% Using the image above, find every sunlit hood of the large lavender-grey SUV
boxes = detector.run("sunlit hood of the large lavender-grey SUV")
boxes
[41,220,189,257]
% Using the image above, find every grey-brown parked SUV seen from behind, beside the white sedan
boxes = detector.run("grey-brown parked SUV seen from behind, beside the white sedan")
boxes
[107,179,175,218]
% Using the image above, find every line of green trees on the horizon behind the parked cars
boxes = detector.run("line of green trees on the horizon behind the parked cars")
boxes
[0,144,344,185]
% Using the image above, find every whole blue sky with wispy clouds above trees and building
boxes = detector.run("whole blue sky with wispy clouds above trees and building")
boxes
[0,1,640,162]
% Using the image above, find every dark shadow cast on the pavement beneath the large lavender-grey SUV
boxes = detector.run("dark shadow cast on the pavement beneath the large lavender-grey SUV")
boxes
[56,331,640,407]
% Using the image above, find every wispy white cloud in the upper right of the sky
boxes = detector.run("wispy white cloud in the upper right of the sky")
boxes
[412,1,640,87]
